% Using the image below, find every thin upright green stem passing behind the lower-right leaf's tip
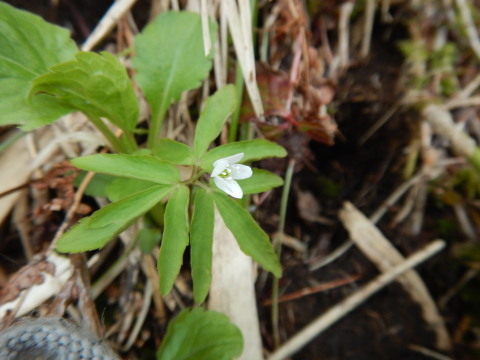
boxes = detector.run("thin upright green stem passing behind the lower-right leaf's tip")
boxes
[272,159,295,348]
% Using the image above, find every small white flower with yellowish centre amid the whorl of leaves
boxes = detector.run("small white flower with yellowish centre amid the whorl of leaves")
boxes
[210,153,252,199]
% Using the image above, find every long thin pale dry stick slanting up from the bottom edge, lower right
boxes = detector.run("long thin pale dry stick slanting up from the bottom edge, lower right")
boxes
[267,240,445,360]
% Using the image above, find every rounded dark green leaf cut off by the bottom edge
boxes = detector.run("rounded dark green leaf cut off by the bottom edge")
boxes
[157,308,243,360]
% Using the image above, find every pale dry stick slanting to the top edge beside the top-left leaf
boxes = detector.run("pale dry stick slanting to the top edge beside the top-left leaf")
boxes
[82,0,137,51]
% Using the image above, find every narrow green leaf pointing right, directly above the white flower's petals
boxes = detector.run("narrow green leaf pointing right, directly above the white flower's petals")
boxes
[201,139,287,171]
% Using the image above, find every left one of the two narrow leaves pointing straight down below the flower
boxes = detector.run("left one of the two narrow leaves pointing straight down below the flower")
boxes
[157,186,190,295]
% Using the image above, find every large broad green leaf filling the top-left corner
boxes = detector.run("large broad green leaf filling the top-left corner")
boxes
[0,2,77,130]
